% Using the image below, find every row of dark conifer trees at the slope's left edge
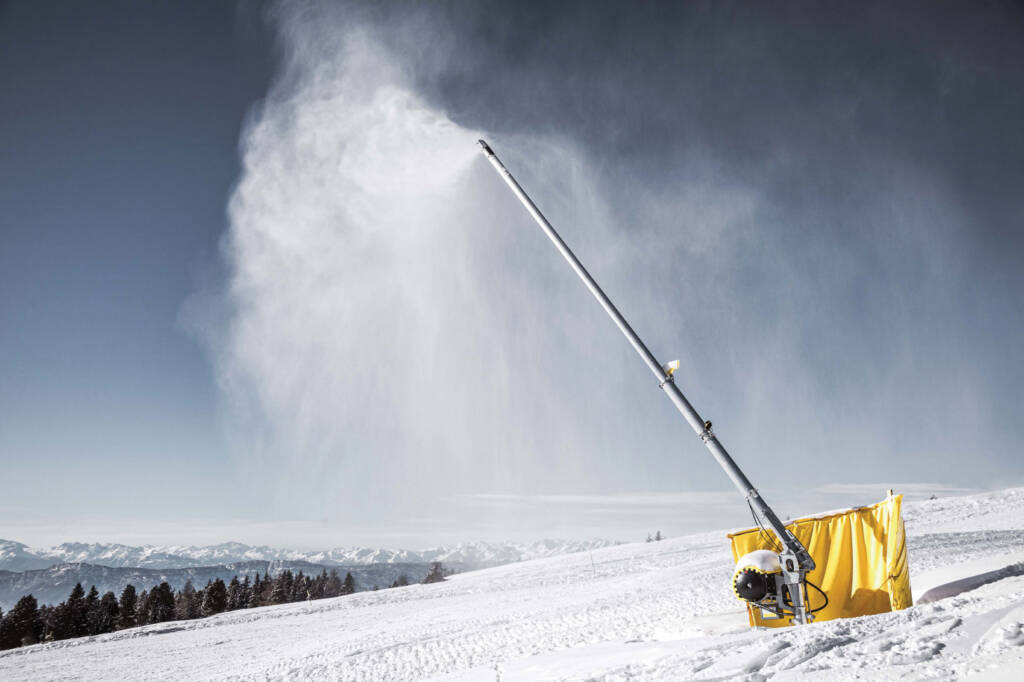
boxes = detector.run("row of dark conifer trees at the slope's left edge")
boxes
[0,569,355,649]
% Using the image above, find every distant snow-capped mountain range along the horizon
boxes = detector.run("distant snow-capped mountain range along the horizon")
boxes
[0,540,618,571]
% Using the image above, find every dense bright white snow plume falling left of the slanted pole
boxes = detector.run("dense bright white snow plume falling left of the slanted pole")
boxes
[217,9,651,519]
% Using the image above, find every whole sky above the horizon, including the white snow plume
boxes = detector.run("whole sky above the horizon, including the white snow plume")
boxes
[0,2,1024,546]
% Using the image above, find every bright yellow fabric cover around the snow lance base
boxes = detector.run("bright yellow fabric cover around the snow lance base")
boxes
[729,495,913,628]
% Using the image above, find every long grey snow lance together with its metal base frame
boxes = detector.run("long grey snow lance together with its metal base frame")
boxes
[478,139,814,625]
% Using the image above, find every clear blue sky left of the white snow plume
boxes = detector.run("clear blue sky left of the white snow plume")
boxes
[0,3,272,518]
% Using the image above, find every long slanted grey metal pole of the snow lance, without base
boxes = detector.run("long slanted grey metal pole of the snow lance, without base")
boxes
[478,139,814,620]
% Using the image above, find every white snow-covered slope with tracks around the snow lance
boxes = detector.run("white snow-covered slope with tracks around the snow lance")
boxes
[0,488,1024,680]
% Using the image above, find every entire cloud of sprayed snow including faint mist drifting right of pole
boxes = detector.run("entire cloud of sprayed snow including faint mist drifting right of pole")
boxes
[201,3,992,545]
